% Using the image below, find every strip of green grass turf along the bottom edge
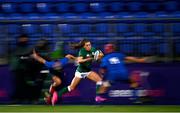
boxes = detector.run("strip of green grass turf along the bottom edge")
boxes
[0,105,180,112]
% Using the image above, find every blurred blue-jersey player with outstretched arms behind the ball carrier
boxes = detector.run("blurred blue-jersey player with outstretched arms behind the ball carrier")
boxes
[32,50,76,105]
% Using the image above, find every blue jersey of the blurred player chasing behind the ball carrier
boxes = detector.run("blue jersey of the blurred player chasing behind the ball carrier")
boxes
[45,58,69,68]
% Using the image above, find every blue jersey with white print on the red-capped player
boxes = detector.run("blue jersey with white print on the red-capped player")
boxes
[100,53,128,78]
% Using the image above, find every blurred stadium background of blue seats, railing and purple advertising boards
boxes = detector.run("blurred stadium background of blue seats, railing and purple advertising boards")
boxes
[0,0,180,111]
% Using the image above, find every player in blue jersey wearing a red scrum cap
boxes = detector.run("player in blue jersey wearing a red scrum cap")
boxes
[97,44,146,101]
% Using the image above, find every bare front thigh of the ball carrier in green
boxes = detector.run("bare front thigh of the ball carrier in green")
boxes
[87,71,102,82]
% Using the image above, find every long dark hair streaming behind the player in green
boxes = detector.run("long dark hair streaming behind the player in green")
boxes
[69,39,90,49]
